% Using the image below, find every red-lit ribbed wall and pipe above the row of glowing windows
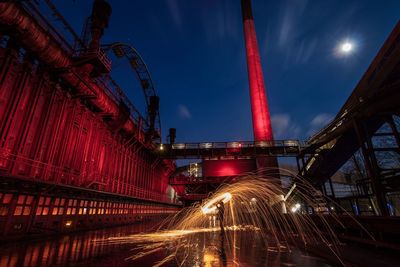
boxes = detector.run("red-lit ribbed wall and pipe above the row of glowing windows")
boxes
[0,2,175,203]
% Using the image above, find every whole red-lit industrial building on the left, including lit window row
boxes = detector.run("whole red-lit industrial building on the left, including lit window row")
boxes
[0,1,179,241]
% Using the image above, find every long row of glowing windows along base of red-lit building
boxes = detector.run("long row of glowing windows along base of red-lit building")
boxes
[0,193,177,219]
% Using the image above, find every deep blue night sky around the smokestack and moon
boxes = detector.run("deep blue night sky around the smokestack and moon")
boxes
[54,0,400,142]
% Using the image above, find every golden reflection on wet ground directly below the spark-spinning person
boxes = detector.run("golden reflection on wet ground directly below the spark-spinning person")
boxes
[171,231,331,266]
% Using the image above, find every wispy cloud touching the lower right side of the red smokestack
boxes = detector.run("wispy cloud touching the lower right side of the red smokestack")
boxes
[271,113,301,139]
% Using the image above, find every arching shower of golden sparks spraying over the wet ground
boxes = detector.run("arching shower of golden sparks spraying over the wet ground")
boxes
[96,170,372,266]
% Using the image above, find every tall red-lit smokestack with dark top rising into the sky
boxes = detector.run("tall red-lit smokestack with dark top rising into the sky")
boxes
[241,0,274,141]
